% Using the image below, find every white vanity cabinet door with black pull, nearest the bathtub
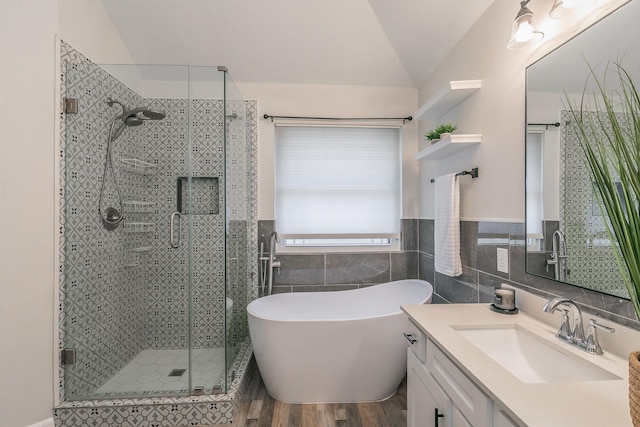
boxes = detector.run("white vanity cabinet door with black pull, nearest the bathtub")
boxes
[407,349,455,427]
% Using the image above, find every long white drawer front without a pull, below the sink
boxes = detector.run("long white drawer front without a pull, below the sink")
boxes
[426,340,493,426]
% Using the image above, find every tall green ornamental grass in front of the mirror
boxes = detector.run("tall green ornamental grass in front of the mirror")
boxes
[565,63,640,319]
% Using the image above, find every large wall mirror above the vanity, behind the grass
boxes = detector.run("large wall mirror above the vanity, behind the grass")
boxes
[525,1,640,298]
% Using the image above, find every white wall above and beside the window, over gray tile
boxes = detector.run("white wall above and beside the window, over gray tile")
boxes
[235,81,418,220]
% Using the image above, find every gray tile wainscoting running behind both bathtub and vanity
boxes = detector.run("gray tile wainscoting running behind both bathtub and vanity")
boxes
[258,219,640,329]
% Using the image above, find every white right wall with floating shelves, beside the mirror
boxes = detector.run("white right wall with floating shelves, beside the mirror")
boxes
[419,0,624,221]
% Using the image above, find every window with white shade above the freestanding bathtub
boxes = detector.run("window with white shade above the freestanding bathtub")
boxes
[275,125,402,247]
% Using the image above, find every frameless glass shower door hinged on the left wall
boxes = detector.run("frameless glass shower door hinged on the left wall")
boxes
[60,58,195,400]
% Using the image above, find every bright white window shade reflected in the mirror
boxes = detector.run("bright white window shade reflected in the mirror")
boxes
[526,132,543,239]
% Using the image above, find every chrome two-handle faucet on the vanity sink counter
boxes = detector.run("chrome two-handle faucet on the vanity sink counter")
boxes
[542,297,615,354]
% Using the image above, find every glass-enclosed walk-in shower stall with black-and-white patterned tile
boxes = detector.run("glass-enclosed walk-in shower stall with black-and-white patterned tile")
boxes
[59,42,258,412]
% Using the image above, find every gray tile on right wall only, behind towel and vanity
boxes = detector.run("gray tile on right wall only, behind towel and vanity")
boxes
[419,219,640,329]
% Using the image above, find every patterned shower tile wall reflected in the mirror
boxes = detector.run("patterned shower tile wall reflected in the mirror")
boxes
[560,111,628,298]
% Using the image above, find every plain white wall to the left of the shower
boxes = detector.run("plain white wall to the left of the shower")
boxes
[0,0,57,427]
